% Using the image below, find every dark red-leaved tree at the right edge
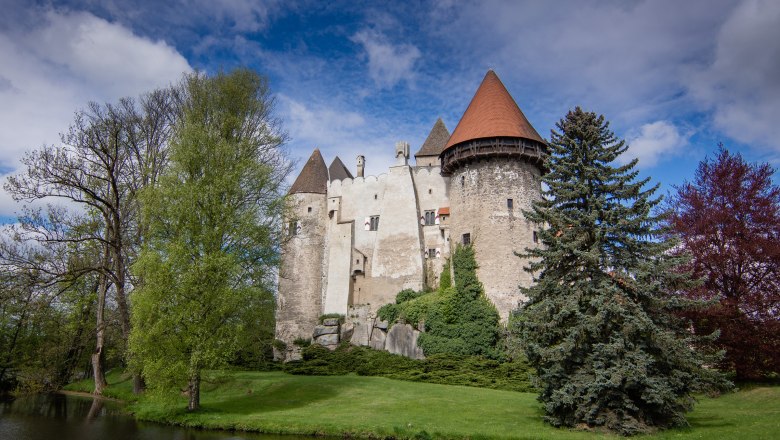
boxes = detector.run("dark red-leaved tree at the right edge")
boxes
[668,146,780,379]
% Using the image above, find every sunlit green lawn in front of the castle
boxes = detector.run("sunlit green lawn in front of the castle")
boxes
[65,372,780,439]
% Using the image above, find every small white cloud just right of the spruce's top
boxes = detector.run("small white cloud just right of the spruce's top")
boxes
[620,121,689,169]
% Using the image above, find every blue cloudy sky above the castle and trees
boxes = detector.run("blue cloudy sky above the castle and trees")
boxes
[0,0,780,222]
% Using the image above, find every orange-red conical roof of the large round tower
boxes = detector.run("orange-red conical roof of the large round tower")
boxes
[444,70,544,150]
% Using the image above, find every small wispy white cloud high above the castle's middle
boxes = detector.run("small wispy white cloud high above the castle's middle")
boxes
[352,29,421,88]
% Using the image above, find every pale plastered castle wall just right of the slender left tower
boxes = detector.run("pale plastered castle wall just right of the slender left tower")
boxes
[325,166,424,314]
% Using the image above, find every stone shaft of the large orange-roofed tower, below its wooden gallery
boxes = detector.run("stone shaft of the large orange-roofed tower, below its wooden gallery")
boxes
[449,158,540,322]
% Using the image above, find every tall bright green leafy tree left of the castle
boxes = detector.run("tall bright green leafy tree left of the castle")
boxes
[130,70,289,410]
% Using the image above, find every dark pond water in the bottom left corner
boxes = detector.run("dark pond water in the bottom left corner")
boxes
[0,394,320,440]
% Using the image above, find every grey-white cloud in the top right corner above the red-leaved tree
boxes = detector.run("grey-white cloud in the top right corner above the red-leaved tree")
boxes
[688,0,780,152]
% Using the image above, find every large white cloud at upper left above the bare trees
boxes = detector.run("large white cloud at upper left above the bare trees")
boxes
[0,9,190,216]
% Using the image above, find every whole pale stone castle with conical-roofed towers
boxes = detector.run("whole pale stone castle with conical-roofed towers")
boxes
[276,70,547,359]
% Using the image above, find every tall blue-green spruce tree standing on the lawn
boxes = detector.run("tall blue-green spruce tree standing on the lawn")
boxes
[514,107,720,435]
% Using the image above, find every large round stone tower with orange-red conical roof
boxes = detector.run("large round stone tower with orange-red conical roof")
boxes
[439,70,547,321]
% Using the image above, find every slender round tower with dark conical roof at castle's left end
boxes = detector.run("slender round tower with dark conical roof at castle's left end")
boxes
[275,149,328,360]
